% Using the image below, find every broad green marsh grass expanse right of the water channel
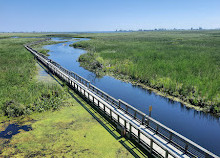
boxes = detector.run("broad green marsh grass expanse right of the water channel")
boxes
[72,31,220,113]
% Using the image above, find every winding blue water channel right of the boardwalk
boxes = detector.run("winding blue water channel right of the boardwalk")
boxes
[45,38,220,156]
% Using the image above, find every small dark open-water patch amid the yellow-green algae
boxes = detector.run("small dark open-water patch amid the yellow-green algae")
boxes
[0,124,32,139]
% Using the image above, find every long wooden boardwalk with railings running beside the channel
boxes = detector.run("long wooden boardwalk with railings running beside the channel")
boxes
[25,38,218,158]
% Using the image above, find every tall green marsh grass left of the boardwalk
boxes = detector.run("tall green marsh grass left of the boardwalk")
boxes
[0,38,65,117]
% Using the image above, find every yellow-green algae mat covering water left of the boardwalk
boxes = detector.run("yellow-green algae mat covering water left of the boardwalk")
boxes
[0,92,135,157]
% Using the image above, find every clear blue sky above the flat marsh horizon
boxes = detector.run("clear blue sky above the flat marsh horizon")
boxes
[0,0,220,32]
